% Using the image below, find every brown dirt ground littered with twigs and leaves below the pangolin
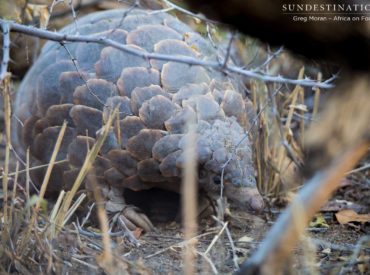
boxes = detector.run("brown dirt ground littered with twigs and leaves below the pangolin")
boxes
[31,182,370,274]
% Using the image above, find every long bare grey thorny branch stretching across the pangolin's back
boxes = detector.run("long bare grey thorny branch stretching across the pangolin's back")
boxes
[0,19,334,89]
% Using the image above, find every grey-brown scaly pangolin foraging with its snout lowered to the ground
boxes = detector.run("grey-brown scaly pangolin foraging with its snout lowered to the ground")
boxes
[13,9,264,231]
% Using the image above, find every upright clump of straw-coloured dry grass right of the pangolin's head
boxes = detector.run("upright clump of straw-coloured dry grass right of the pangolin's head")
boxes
[251,68,305,197]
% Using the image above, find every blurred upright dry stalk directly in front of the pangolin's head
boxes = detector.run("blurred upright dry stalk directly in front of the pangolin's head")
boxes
[182,122,198,275]
